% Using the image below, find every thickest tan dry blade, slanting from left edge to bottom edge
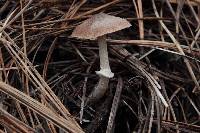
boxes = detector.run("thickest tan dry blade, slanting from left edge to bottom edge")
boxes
[0,82,83,133]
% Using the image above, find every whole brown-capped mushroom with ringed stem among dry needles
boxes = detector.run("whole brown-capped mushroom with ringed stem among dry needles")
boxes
[71,13,131,100]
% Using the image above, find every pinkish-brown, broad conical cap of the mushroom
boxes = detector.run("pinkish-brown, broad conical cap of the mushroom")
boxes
[71,13,131,39]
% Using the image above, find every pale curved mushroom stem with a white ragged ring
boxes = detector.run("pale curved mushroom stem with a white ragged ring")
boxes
[89,35,114,100]
